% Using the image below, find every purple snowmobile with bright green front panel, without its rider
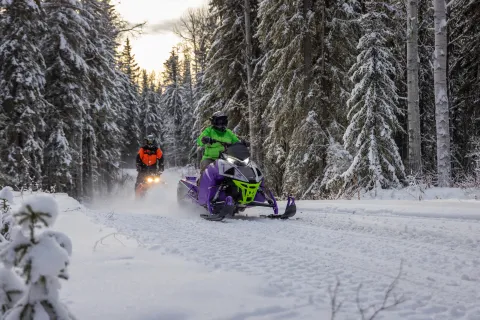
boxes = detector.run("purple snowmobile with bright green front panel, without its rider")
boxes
[177,140,297,221]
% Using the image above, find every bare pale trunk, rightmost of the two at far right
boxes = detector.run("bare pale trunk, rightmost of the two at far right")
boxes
[433,0,452,187]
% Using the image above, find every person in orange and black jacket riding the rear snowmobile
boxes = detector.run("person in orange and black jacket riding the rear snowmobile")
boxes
[135,135,164,189]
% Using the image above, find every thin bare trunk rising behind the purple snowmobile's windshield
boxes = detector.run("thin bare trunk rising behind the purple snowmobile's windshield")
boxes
[244,0,255,160]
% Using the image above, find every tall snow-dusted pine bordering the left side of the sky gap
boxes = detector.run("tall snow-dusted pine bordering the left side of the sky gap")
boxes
[94,1,126,195]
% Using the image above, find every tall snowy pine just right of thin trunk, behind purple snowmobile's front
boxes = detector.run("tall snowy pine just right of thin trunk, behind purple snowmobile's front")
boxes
[257,0,305,193]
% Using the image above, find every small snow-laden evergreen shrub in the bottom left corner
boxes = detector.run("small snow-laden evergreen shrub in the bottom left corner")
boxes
[0,195,75,320]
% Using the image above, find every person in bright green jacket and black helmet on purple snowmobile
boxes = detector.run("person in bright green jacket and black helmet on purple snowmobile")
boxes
[197,112,240,176]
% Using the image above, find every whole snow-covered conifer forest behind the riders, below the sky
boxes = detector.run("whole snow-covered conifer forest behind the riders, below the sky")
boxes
[0,0,480,200]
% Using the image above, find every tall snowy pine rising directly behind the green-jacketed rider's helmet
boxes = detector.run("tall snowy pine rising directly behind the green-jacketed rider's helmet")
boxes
[199,0,258,136]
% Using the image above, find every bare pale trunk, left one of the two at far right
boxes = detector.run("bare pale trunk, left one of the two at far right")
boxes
[407,0,422,174]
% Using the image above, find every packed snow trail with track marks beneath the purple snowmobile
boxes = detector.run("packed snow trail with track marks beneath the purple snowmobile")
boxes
[89,172,480,320]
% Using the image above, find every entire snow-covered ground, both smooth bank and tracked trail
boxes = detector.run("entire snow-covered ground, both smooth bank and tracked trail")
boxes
[4,172,480,320]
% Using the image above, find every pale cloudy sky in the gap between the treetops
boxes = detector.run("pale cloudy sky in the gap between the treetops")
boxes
[113,0,208,72]
